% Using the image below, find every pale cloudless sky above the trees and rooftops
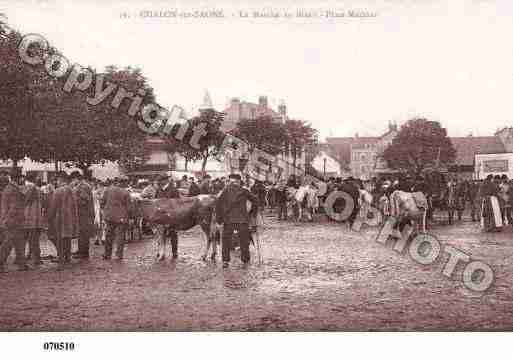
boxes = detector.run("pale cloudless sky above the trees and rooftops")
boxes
[0,0,513,138]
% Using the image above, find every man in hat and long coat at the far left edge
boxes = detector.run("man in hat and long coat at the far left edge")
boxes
[0,170,29,271]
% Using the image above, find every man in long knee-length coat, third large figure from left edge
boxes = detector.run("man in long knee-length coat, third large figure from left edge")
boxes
[48,172,78,265]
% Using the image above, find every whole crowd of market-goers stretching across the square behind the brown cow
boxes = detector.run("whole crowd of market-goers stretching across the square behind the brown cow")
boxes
[0,171,513,270]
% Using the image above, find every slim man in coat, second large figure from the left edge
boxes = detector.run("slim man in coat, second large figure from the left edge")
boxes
[25,173,45,265]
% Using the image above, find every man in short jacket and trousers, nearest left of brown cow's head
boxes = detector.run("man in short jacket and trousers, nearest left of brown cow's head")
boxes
[100,182,131,260]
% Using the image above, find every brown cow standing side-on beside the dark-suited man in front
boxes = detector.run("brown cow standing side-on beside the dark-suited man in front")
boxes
[132,194,220,261]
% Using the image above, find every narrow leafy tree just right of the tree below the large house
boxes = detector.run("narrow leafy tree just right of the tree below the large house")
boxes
[285,120,318,172]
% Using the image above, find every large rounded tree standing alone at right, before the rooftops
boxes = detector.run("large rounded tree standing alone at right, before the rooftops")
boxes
[383,118,456,174]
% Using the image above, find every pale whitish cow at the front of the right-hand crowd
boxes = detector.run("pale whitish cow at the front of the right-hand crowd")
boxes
[390,190,428,233]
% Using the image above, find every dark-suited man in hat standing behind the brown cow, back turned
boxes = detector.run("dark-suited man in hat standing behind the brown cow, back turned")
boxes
[216,174,258,268]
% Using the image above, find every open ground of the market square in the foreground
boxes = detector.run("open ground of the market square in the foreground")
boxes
[0,212,513,331]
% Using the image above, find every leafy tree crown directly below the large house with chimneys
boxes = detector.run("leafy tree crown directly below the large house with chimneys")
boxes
[231,116,287,155]
